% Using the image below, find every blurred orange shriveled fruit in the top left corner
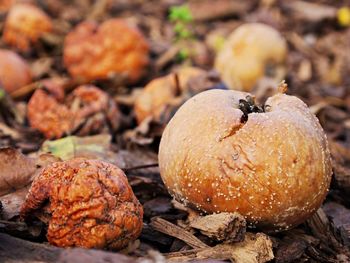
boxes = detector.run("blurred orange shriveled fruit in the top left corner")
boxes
[2,3,52,52]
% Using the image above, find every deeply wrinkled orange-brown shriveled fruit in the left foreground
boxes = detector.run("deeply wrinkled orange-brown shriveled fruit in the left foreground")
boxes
[21,158,143,249]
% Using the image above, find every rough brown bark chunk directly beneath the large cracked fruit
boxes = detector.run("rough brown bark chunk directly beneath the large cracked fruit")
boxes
[190,213,246,242]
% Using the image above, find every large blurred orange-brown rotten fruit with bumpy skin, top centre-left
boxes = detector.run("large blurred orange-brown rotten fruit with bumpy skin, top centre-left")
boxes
[63,19,149,82]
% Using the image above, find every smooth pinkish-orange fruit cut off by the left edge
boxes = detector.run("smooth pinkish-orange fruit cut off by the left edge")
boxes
[0,49,32,93]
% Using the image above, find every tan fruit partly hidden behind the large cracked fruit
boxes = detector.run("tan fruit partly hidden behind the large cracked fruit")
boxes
[134,67,221,124]
